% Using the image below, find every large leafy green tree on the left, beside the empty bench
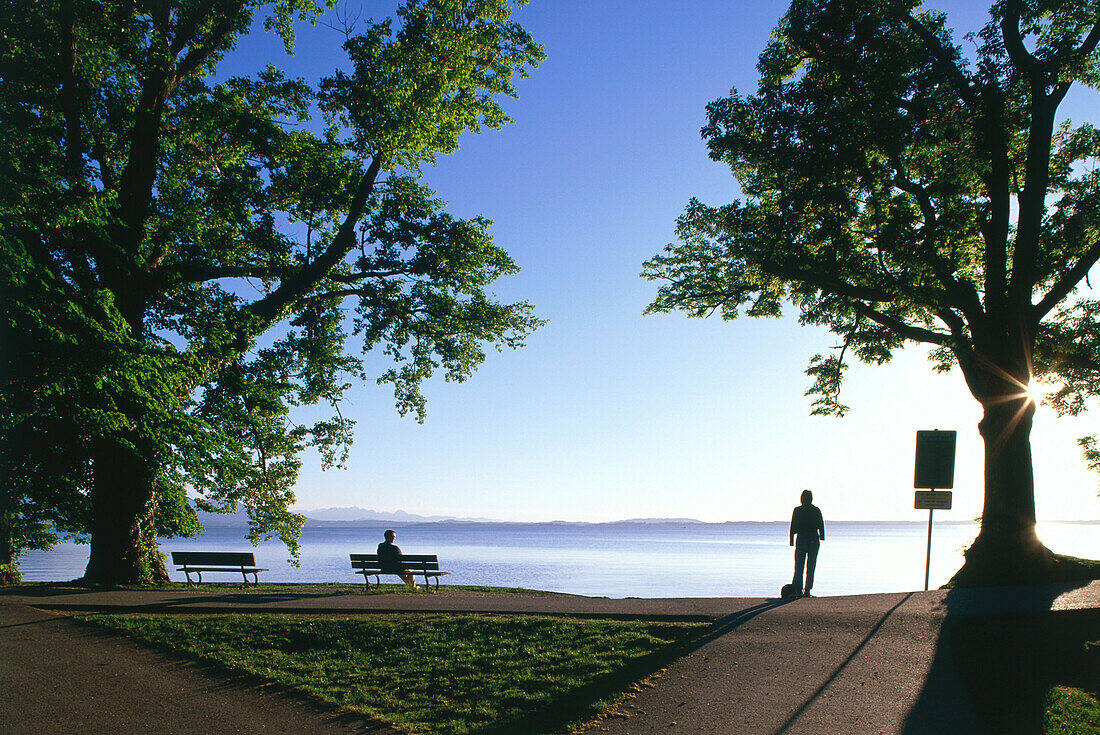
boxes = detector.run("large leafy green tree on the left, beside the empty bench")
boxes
[0,0,543,583]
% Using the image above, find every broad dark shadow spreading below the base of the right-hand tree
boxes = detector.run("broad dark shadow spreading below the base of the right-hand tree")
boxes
[903,585,1100,735]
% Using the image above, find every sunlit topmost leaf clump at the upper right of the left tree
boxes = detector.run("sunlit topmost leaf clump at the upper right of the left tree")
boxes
[321,0,542,168]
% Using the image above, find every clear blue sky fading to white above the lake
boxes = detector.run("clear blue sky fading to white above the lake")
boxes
[227,0,1100,522]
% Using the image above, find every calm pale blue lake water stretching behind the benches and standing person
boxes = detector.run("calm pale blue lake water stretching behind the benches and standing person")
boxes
[20,522,1100,597]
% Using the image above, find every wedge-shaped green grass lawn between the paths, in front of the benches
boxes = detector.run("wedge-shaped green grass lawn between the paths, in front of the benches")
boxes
[83,615,708,735]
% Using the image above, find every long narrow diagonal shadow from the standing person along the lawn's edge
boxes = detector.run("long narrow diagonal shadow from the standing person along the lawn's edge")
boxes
[474,600,793,735]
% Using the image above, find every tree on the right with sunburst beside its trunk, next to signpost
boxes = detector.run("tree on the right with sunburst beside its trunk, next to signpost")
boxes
[644,0,1100,582]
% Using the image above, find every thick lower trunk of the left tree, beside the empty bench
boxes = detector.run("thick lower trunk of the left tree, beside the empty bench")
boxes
[84,438,168,585]
